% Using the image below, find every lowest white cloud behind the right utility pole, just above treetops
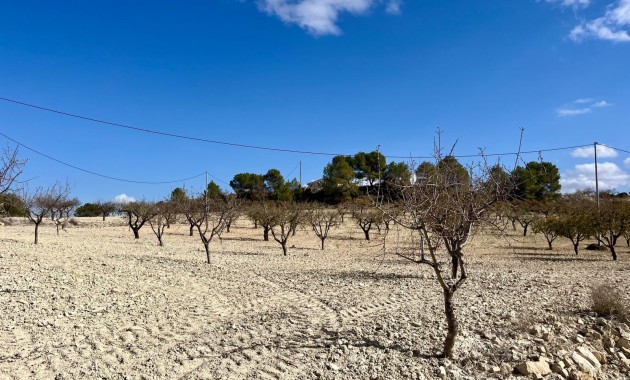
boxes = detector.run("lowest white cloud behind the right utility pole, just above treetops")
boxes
[560,162,630,193]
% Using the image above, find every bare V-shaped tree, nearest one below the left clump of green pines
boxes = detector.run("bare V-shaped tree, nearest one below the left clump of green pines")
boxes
[263,202,302,256]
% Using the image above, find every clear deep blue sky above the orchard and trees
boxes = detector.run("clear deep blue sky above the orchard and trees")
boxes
[0,0,630,202]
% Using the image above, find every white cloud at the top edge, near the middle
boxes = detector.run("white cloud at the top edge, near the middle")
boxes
[258,0,402,36]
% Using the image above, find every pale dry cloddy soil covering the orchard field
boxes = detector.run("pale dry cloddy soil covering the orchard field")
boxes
[0,218,630,379]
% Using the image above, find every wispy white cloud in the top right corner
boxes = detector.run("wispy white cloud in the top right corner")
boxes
[569,0,630,42]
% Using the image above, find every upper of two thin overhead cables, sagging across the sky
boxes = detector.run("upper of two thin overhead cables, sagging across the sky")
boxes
[0,97,621,160]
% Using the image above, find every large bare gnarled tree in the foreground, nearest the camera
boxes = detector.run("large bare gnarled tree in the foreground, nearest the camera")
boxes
[388,144,503,358]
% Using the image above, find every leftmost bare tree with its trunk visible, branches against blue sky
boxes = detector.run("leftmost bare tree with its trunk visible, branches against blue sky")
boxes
[22,183,70,244]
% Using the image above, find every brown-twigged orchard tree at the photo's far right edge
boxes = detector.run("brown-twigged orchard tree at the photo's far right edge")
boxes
[595,198,630,261]
